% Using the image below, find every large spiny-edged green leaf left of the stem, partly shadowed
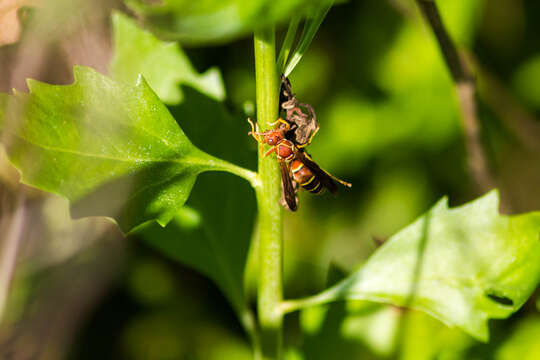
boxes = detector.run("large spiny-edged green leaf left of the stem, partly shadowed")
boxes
[0,67,240,232]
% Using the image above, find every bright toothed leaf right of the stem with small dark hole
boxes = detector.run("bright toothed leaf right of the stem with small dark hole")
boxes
[284,191,540,341]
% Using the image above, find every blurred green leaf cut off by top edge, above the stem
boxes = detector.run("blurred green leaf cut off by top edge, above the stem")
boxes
[126,0,334,44]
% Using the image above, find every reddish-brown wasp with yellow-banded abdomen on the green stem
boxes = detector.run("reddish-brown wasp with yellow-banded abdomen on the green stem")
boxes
[248,118,352,211]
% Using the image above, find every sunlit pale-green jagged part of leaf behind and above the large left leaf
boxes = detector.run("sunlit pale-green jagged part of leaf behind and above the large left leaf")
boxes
[111,12,225,104]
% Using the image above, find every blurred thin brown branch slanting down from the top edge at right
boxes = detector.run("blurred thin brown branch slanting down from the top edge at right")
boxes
[416,0,495,192]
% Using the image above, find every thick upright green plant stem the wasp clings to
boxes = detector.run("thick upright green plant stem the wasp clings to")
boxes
[254,27,283,359]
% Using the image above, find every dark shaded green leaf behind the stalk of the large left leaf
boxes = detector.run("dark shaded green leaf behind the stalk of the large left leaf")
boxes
[134,88,256,325]
